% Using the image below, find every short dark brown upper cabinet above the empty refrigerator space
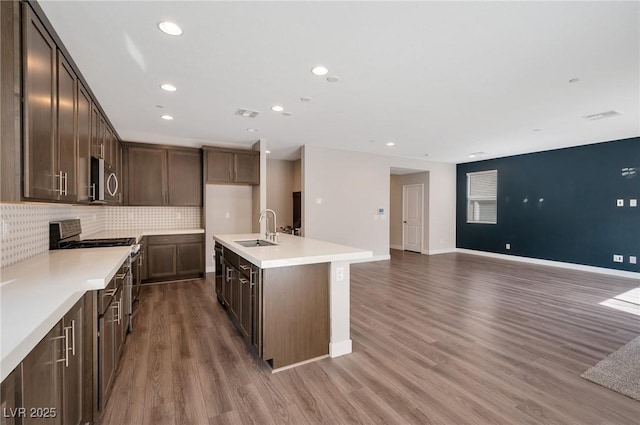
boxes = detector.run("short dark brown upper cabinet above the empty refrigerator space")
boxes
[203,147,260,185]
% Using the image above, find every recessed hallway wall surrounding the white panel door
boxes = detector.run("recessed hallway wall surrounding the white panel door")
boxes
[389,172,429,252]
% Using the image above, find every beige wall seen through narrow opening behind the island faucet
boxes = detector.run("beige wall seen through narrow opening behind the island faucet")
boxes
[267,159,293,227]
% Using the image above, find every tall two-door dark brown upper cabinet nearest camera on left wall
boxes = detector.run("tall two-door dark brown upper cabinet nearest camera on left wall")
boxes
[23,3,78,202]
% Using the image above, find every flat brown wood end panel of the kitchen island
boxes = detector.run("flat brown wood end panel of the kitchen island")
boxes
[262,263,329,369]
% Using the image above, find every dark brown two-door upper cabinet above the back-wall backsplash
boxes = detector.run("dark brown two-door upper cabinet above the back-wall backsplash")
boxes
[126,144,202,206]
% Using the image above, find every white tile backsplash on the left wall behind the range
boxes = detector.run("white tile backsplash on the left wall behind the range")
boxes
[0,203,106,268]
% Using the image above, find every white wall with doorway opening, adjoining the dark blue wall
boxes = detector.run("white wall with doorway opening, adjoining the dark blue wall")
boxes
[302,146,456,258]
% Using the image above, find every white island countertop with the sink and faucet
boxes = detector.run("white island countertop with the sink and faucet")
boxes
[213,233,373,269]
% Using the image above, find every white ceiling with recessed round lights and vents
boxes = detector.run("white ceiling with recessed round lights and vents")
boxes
[40,1,640,163]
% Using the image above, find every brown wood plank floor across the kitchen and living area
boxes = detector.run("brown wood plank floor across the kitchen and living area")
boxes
[98,251,640,425]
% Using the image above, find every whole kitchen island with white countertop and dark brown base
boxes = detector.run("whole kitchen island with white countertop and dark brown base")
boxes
[213,233,373,370]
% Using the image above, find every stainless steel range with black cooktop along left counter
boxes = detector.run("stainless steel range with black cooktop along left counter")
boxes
[49,219,142,332]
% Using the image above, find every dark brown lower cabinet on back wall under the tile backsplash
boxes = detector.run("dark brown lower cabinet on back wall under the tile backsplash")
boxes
[144,233,204,282]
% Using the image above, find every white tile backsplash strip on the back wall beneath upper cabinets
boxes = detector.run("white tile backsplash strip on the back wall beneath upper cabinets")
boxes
[106,207,201,230]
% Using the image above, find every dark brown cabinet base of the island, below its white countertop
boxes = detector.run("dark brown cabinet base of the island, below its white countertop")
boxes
[216,243,329,369]
